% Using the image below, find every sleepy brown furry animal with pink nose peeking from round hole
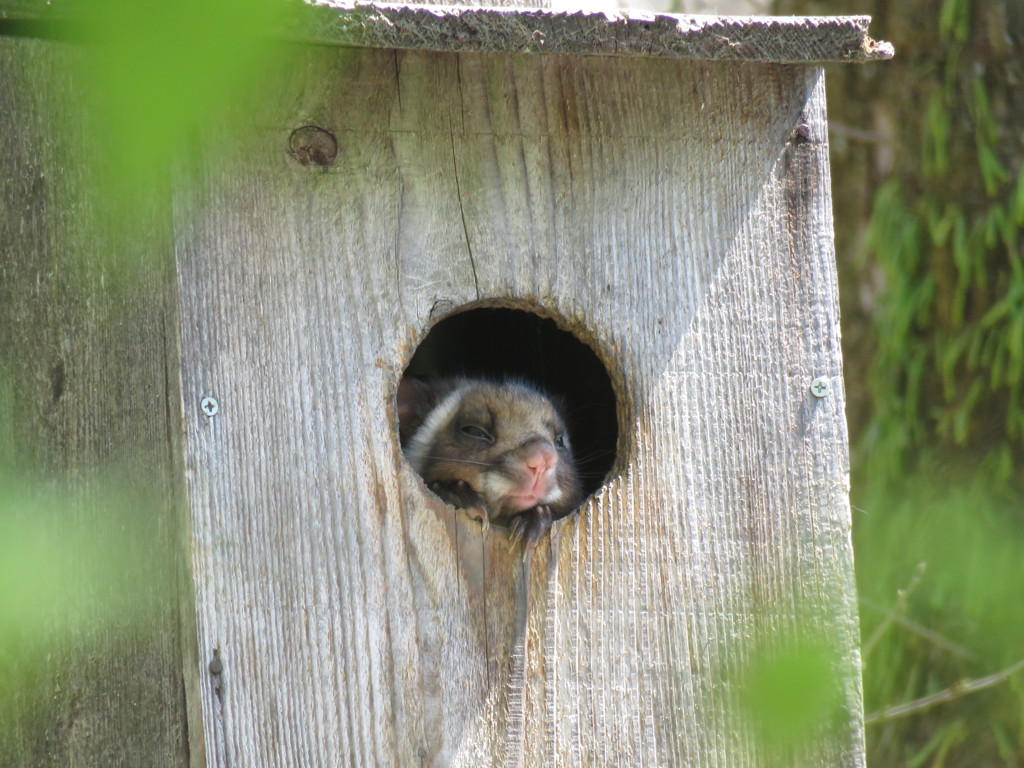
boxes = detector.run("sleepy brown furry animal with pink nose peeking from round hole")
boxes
[398,377,583,546]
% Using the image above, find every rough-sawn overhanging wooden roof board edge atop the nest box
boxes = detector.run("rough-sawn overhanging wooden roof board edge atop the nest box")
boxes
[290,0,893,63]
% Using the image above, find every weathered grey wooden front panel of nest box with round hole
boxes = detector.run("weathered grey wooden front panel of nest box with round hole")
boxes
[175,48,863,767]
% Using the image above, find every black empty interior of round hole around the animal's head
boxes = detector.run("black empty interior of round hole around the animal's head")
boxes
[406,307,618,505]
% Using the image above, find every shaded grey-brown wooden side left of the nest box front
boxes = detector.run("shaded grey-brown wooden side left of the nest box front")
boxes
[0,38,196,768]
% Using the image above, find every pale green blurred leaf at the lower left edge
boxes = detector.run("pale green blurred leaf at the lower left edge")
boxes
[0,468,175,695]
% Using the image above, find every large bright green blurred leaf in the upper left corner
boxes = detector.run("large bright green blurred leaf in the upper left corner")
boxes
[83,0,286,195]
